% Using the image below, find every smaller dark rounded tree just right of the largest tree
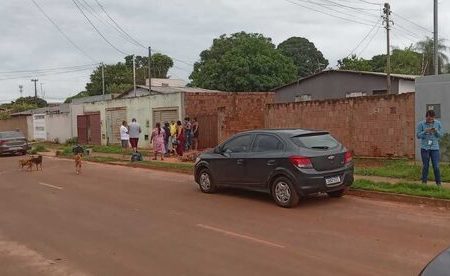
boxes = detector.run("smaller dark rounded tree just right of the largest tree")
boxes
[277,37,328,77]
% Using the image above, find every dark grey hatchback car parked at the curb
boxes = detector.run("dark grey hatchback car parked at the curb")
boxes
[195,129,353,207]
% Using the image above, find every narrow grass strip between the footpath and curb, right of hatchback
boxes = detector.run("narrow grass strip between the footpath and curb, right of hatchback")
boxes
[352,180,450,200]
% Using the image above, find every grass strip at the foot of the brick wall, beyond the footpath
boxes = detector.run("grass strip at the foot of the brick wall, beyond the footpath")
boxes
[355,160,450,182]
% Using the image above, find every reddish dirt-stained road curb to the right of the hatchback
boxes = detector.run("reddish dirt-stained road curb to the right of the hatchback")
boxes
[347,188,450,209]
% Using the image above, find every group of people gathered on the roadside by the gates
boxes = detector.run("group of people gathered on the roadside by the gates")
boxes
[120,117,199,160]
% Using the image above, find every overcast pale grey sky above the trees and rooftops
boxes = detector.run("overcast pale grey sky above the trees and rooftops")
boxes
[0,0,450,102]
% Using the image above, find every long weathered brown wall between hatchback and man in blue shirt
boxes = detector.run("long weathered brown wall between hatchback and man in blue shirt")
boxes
[265,93,415,158]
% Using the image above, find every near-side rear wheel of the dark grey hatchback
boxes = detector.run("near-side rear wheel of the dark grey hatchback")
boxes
[271,177,300,208]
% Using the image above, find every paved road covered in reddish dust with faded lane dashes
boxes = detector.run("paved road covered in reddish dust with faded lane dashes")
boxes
[0,157,450,276]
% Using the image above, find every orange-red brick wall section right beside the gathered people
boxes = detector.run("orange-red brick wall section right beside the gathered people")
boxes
[184,92,274,146]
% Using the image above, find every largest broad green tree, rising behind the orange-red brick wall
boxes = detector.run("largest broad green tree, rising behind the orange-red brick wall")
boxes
[189,32,297,91]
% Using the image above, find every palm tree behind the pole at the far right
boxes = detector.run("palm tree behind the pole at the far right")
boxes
[416,37,449,75]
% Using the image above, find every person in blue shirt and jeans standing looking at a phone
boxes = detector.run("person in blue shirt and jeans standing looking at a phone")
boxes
[417,110,443,186]
